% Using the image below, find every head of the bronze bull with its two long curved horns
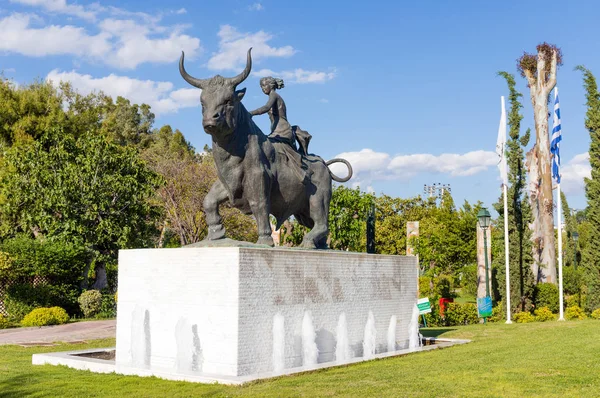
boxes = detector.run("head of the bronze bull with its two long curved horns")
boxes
[179,48,252,137]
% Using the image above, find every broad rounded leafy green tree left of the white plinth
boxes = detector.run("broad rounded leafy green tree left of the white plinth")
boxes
[0,129,160,289]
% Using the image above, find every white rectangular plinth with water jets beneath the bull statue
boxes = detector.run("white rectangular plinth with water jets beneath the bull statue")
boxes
[115,247,418,376]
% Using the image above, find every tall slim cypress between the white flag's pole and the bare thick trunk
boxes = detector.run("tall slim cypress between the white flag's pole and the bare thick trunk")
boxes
[494,72,534,311]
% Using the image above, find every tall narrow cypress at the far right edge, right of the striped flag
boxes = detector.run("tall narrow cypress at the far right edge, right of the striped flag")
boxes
[576,65,600,311]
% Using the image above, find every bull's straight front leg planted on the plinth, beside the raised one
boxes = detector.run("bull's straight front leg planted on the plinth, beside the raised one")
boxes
[246,173,275,246]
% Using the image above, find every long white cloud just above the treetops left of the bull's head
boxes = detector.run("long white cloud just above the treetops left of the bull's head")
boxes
[46,69,201,115]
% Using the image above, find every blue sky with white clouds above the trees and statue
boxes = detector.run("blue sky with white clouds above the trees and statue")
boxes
[0,0,600,208]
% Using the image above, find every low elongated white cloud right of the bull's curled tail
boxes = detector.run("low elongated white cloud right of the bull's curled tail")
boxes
[331,148,497,186]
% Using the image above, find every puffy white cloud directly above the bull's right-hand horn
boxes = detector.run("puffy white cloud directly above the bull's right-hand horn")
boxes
[207,25,296,70]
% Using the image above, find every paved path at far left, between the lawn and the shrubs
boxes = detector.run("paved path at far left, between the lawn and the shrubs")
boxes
[0,320,117,345]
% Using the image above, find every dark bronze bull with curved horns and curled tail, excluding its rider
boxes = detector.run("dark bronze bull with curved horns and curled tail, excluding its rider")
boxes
[179,49,352,249]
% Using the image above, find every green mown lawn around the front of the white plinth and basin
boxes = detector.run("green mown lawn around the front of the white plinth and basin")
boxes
[0,320,600,398]
